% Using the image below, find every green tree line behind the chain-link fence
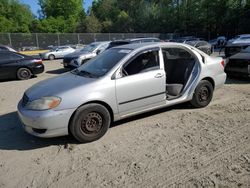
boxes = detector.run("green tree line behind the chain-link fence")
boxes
[0,0,250,38]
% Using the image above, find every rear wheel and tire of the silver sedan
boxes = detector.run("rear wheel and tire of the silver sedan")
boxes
[191,80,214,108]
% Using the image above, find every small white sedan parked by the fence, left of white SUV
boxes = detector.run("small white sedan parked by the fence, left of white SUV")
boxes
[39,46,75,60]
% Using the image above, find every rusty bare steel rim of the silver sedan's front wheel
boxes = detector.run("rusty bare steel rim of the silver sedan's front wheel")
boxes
[81,112,103,134]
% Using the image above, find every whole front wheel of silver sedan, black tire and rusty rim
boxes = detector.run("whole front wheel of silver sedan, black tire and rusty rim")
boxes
[69,103,111,143]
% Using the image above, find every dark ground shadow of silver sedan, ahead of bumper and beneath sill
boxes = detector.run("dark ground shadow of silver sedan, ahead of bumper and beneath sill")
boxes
[0,103,193,151]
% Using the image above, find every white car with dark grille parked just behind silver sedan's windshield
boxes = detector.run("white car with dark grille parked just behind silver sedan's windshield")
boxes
[63,41,110,68]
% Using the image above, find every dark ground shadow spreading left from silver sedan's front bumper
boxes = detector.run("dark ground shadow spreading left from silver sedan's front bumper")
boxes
[0,112,77,150]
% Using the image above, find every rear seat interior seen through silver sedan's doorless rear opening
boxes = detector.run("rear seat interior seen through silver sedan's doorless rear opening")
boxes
[162,48,195,99]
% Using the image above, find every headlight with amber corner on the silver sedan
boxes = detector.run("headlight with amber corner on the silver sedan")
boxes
[26,97,61,110]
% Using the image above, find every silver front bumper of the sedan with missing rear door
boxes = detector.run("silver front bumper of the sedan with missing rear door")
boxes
[18,101,75,138]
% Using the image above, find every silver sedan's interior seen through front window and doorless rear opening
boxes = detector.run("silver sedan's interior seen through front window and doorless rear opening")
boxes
[122,48,195,100]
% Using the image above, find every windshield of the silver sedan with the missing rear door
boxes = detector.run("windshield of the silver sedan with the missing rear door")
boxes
[72,48,132,78]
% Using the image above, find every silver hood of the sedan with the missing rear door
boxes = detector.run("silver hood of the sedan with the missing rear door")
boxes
[25,72,96,100]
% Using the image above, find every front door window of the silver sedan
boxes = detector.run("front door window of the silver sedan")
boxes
[123,51,160,76]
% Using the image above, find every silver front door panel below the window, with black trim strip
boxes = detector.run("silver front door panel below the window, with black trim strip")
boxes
[116,69,166,116]
